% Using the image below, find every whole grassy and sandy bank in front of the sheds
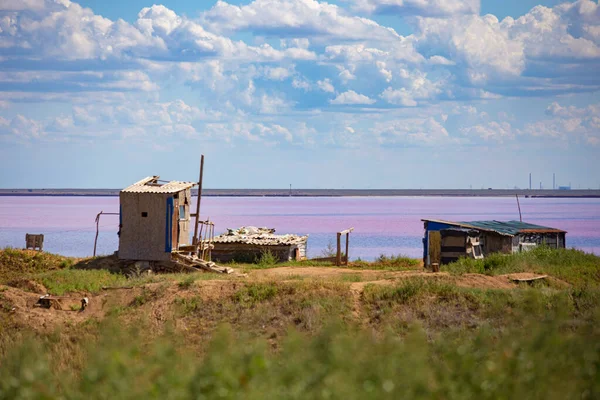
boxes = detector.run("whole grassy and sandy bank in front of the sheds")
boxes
[0,249,600,399]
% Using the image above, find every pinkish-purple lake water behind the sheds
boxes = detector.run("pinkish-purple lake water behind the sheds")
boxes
[0,197,600,260]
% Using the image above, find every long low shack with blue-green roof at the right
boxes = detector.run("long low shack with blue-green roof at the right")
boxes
[422,219,567,267]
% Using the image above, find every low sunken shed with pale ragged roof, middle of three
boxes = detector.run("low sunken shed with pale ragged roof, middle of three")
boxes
[212,226,308,263]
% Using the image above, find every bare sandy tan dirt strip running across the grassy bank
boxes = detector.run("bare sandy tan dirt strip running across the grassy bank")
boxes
[0,267,555,331]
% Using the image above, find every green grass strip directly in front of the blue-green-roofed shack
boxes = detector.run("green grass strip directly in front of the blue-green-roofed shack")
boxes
[441,247,600,285]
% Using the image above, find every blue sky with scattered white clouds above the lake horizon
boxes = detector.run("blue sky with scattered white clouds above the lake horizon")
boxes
[0,0,600,189]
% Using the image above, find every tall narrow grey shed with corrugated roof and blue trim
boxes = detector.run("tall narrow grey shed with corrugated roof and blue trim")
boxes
[118,176,196,261]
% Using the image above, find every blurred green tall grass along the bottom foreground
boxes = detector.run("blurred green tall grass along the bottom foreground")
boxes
[0,322,600,400]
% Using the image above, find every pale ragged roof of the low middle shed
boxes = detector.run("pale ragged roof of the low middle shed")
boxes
[214,226,308,246]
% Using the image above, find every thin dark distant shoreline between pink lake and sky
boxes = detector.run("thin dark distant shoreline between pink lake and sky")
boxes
[0,189,600,198]
